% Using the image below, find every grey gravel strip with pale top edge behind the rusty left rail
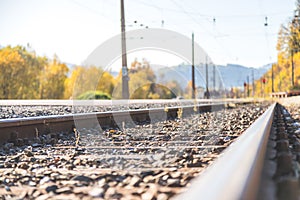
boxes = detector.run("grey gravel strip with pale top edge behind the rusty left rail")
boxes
[0,99,254,119]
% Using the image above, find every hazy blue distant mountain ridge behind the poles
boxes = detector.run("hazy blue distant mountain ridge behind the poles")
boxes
[153,64,272,89]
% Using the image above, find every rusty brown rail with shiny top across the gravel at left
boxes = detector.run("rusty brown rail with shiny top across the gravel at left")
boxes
[0,102,226,144]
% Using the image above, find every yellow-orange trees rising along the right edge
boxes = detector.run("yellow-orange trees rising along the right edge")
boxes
[251,0,300,96]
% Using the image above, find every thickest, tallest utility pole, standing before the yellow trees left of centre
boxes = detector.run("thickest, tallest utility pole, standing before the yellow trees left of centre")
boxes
[121,0,129,99]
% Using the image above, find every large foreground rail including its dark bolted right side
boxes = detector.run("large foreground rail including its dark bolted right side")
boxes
[177,104,300,200]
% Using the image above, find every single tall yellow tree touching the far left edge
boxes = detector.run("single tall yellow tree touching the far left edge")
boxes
[0,46,46,99]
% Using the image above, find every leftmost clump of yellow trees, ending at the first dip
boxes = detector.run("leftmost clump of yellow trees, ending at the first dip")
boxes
[0,46,69,99]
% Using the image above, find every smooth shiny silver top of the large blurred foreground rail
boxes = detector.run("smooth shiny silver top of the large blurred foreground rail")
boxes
[175,103,276,200]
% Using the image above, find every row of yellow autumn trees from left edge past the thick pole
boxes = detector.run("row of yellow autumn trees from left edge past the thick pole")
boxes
[0,45,183,99]
